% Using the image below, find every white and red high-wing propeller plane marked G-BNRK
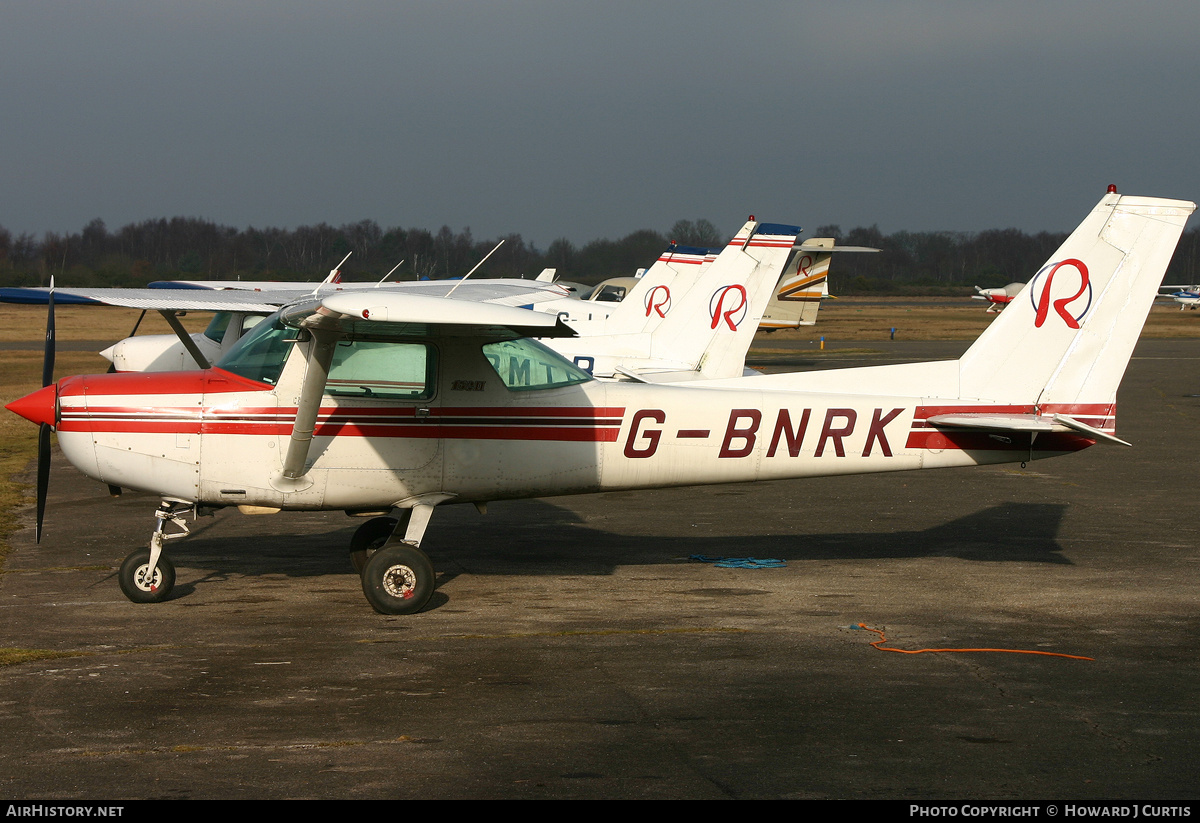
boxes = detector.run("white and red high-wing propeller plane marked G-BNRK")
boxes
[8,190,1195,614]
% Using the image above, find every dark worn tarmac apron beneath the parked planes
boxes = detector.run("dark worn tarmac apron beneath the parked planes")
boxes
[0,341,1200,800]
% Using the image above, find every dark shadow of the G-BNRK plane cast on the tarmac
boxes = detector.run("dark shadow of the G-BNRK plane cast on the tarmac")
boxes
[152,500,1070,599]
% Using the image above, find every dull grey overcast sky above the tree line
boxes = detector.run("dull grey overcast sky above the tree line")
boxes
[0,0,1200,248]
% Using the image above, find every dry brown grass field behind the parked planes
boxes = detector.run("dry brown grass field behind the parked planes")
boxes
[0,298,1200,563]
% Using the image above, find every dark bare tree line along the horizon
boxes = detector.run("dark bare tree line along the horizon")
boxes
[0,217,1200,294]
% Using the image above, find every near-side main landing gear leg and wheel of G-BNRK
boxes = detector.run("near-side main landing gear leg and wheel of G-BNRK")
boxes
[362,504,437,614]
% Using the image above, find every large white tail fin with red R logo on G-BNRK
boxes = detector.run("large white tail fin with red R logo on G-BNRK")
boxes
[959,188,1195,410]
